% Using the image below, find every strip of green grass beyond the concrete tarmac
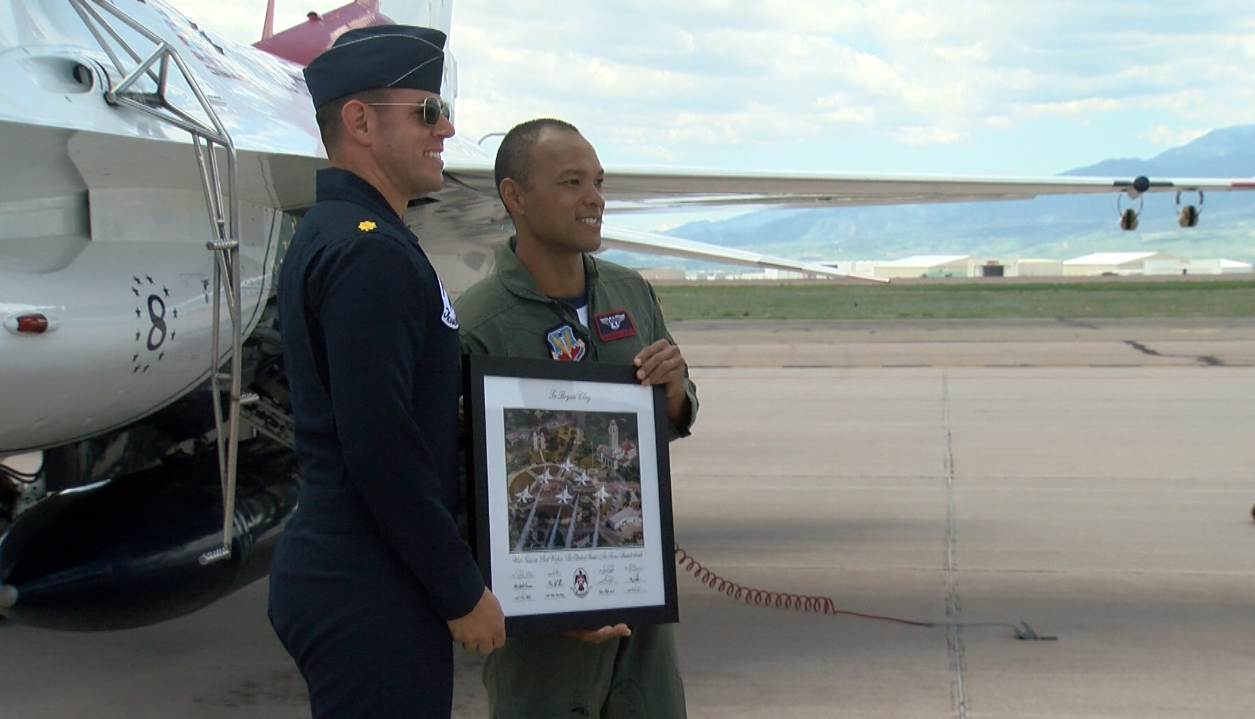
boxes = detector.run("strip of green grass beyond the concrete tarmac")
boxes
[655,279,1255,320]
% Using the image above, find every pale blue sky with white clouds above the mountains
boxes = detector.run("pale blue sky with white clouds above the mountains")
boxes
[188,0,1255,174]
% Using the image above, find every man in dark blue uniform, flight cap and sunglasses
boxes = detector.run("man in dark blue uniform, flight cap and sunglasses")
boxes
[270,25,506,719]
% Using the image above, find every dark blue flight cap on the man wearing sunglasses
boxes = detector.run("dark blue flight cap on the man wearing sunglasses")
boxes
[305,25,446,108]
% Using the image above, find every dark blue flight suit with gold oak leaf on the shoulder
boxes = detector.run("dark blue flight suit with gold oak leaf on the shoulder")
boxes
[270,168,484,719]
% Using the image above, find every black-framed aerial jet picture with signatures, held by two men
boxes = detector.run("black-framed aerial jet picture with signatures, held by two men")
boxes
[464,355,679,636]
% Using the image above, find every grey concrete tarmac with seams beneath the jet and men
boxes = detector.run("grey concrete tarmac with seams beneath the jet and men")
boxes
[0,320,1255,719]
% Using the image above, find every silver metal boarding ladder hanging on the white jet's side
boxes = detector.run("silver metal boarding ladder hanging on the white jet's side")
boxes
[69,0,248,565]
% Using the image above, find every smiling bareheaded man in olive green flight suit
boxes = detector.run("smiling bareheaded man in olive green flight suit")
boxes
[456,119,698,719]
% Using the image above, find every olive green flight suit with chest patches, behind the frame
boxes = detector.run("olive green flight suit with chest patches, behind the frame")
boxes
[456,238,698,719]
